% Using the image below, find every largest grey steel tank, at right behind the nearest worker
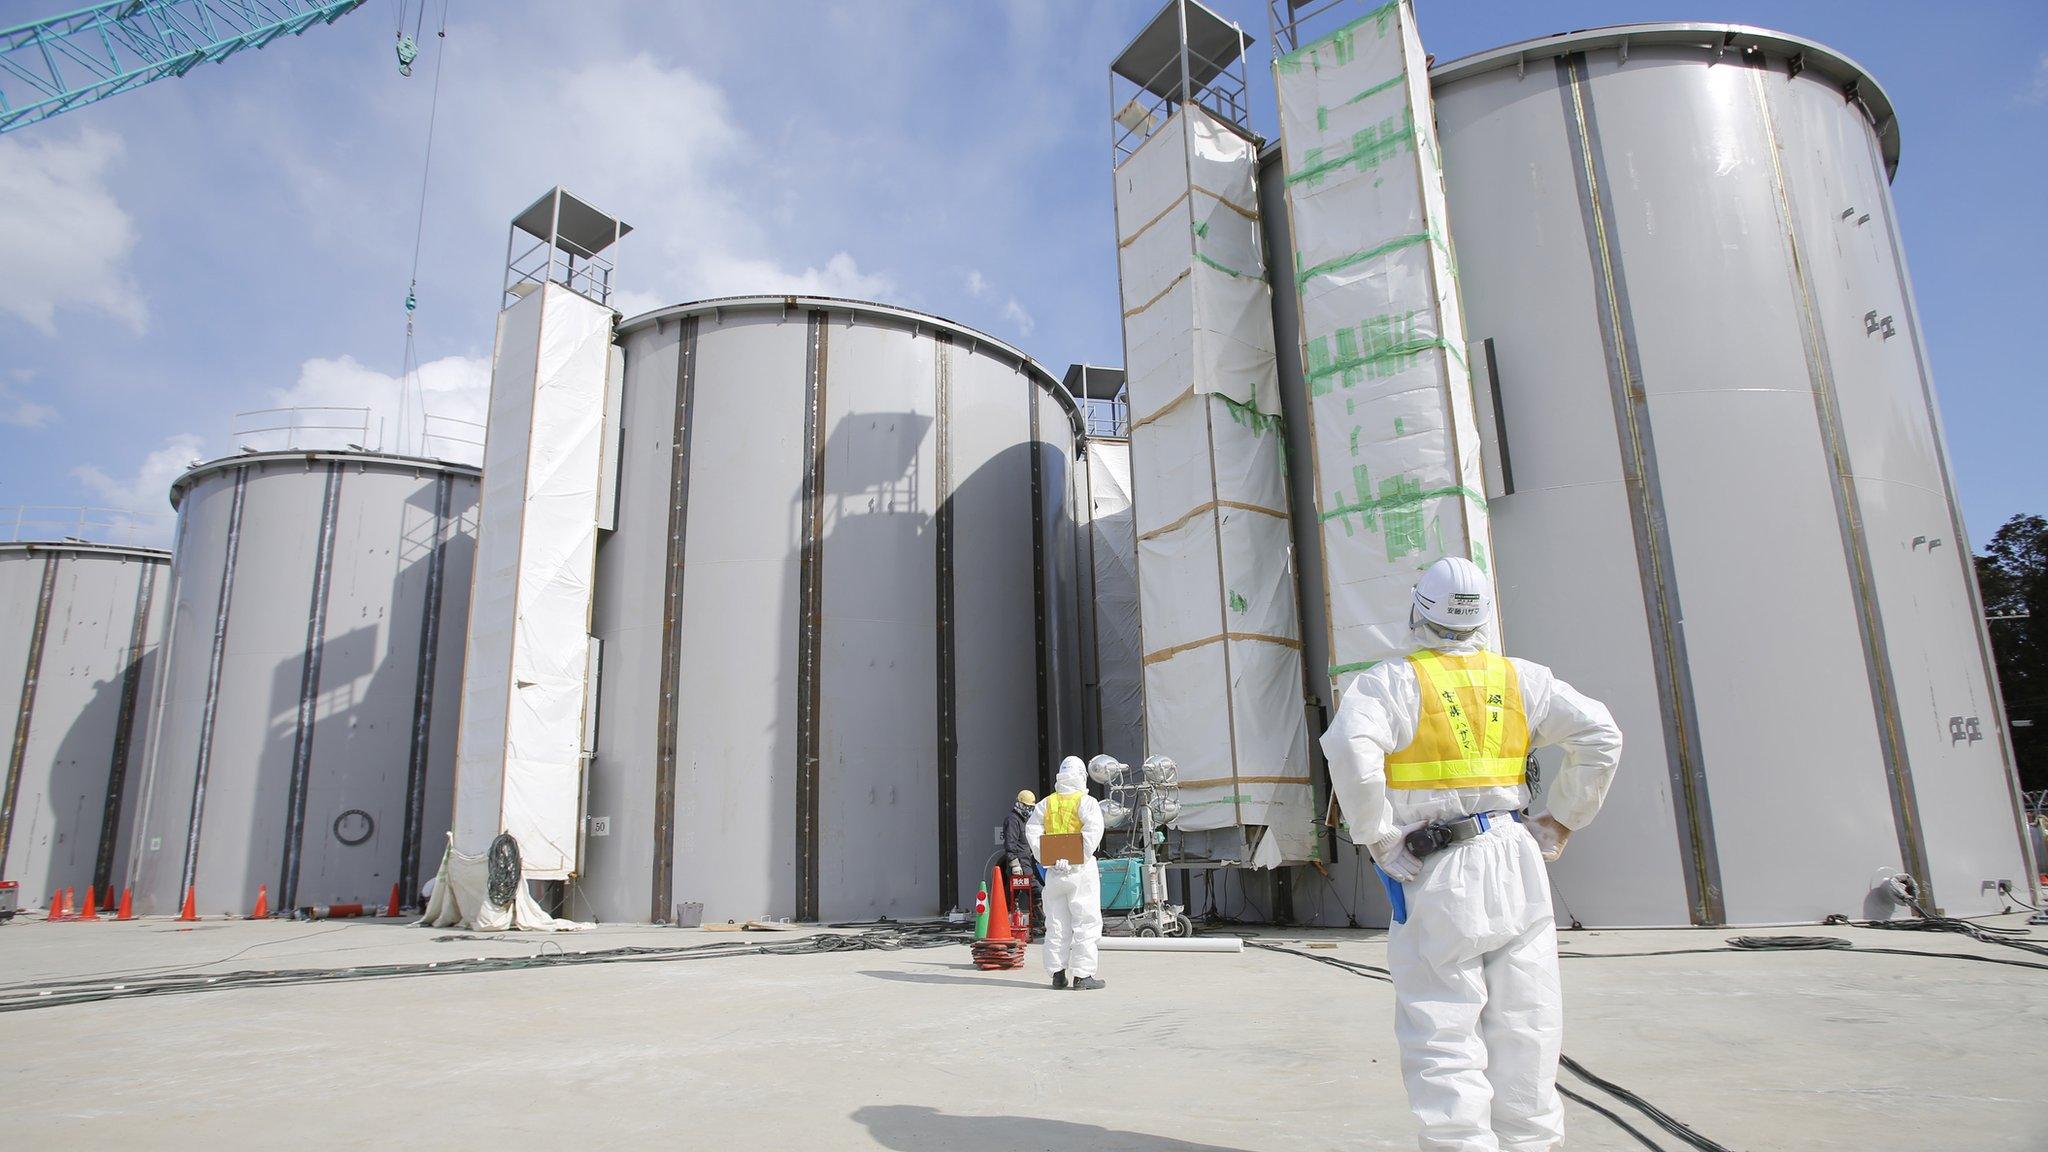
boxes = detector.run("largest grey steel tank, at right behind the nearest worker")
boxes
[1266,25,2034,924]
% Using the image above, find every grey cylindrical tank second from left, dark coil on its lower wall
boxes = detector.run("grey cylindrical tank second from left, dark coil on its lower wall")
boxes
[133,451,477,914]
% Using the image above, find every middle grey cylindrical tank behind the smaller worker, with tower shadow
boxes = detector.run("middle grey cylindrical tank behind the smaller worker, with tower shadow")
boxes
[569,297,1081,920]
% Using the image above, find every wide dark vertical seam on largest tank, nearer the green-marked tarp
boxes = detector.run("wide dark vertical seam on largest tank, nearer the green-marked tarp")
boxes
[1556,53,1726,924]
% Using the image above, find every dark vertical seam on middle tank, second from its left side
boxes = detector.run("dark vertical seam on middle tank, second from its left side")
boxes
[797,312,829,920]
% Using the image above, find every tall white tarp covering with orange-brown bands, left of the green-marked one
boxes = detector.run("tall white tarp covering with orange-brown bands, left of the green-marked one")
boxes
[1116,107,1315,863]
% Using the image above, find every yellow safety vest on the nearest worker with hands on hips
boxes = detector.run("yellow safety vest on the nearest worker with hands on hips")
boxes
[1386,650,1530,789]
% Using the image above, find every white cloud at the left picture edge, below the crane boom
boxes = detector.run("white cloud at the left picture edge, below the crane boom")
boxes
[0,129,150,336]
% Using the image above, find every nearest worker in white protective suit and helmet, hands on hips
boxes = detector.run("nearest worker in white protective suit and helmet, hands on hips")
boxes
[1323,558,1622,1152]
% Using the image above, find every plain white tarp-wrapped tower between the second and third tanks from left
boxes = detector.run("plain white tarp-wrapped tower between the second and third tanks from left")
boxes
[455,283,612,879]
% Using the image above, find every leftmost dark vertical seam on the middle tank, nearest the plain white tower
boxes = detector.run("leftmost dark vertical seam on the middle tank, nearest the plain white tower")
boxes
[649,316,698,924]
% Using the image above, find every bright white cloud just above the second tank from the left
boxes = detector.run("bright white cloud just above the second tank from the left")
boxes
[258,357,492,463]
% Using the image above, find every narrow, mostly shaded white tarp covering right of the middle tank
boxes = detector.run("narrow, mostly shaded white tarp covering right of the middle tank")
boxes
[1085,441,1145,765]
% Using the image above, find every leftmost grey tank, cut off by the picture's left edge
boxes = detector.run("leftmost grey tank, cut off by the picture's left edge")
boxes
[0,543,170,906]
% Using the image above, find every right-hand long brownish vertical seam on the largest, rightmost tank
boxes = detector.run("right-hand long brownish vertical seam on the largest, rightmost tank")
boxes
[1749,68,1939,910]
